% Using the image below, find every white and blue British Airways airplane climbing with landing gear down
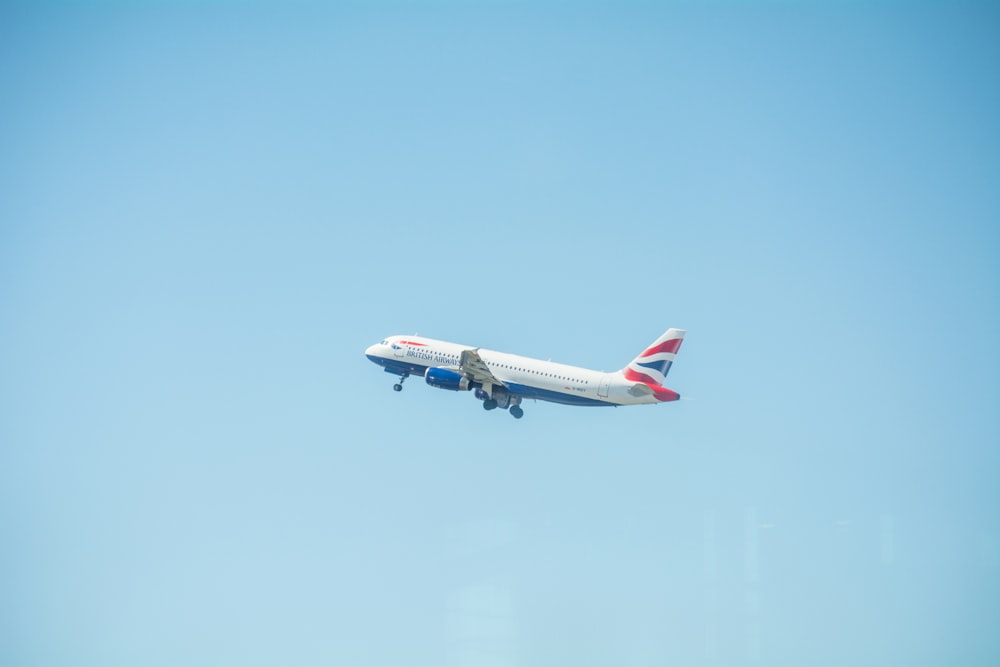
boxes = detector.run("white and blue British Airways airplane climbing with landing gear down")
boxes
[365,329,687,419]
